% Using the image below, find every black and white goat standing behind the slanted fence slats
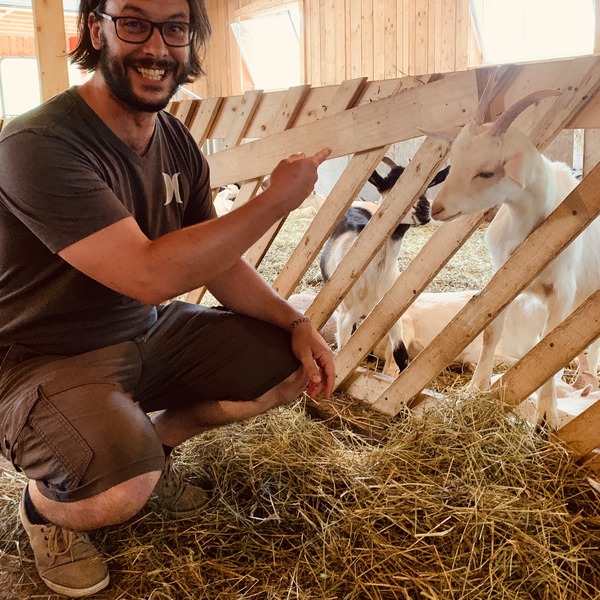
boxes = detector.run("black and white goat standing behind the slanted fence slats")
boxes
[320,157,447,377]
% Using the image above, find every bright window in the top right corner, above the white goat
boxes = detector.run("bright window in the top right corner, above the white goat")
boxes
[471,0,595,64]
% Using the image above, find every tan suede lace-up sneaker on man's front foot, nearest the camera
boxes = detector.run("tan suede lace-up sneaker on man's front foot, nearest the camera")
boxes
[19,491,109,598]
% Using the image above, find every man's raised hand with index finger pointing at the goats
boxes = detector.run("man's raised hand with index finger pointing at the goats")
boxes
[263,148,331,215]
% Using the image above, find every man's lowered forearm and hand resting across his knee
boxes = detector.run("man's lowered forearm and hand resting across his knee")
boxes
[208,259,335,398]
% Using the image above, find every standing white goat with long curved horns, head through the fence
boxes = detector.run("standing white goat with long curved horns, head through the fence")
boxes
[427,86,600,428]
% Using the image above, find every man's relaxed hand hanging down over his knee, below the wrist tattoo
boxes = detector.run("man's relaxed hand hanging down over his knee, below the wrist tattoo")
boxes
[292,321,335,398]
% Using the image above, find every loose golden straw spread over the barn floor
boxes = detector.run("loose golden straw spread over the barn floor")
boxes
[0,212,600,600]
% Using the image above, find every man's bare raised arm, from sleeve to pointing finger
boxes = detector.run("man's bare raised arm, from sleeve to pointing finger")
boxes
[58,148,331,304]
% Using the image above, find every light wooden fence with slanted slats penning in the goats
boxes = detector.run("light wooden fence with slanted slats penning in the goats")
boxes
[170,57,600,474]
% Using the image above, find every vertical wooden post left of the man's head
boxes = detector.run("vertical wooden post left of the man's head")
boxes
[32,0,69,102]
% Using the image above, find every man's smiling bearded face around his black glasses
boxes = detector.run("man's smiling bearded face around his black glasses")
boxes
[92,0,190,112]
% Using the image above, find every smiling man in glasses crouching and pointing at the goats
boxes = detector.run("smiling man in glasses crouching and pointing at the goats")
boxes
[0,0,334,597]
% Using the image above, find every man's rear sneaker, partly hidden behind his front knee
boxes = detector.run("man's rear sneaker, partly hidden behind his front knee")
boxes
[151,456,208,519]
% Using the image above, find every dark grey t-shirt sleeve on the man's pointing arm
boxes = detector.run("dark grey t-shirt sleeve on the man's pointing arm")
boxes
[0,131,131,253]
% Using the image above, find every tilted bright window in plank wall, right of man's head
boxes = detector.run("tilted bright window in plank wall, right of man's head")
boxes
[231,2,302,90]
